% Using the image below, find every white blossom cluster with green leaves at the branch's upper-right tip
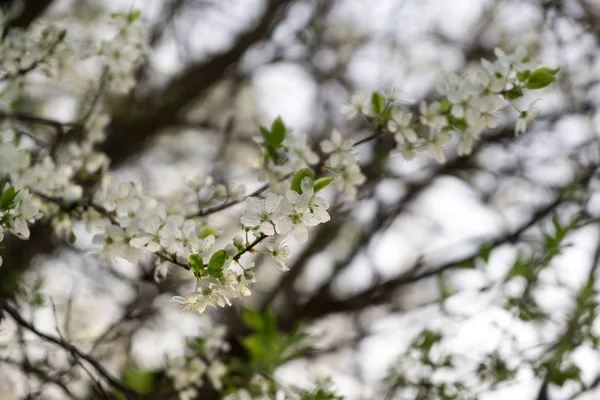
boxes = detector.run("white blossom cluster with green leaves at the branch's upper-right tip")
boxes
[340,47,557,162]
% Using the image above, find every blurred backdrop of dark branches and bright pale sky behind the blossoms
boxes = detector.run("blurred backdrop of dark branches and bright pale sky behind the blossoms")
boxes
[0,0,600,400]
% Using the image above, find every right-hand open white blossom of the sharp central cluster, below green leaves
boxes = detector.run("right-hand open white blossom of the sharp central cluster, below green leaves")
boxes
[273,190,318,243]
